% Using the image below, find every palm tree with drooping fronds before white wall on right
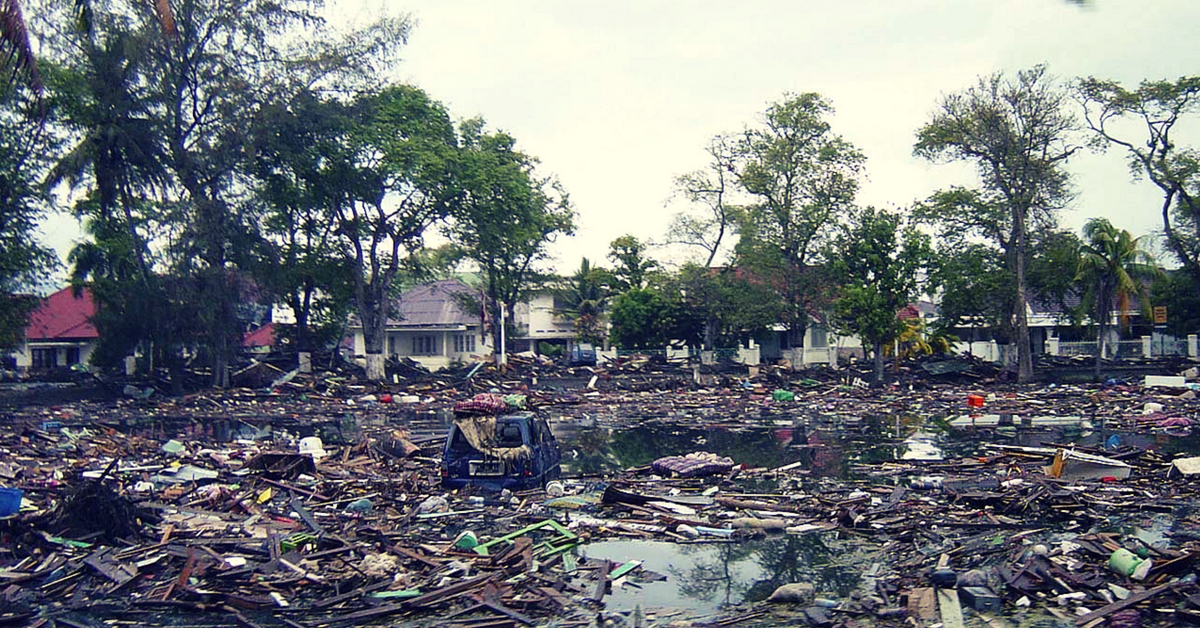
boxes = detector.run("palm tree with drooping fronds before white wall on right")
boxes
[1075,219,1159,379]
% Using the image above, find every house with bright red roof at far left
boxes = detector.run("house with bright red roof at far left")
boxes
[12,288,100,372]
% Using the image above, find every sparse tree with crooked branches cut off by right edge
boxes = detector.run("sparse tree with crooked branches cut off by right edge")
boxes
[1075,76,1200,290]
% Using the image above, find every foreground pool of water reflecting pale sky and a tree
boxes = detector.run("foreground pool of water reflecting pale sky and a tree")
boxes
[580,533,866,614]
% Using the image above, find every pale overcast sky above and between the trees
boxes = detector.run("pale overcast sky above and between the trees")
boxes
[42,0,1200,273]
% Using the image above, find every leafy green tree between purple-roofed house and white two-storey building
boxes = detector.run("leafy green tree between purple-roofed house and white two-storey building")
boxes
[450,119,575,364]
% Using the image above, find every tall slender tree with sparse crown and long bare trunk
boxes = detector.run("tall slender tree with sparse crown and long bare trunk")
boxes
[914,66,1078,382]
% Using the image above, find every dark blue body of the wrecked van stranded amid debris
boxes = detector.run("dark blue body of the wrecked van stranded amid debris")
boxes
[442,412,562,491]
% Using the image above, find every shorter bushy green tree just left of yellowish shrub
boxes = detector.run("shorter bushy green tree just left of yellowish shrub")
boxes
[828,208,932,384]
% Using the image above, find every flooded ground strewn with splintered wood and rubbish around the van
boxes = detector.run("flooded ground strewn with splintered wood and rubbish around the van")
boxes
[0,358,1200,628]
